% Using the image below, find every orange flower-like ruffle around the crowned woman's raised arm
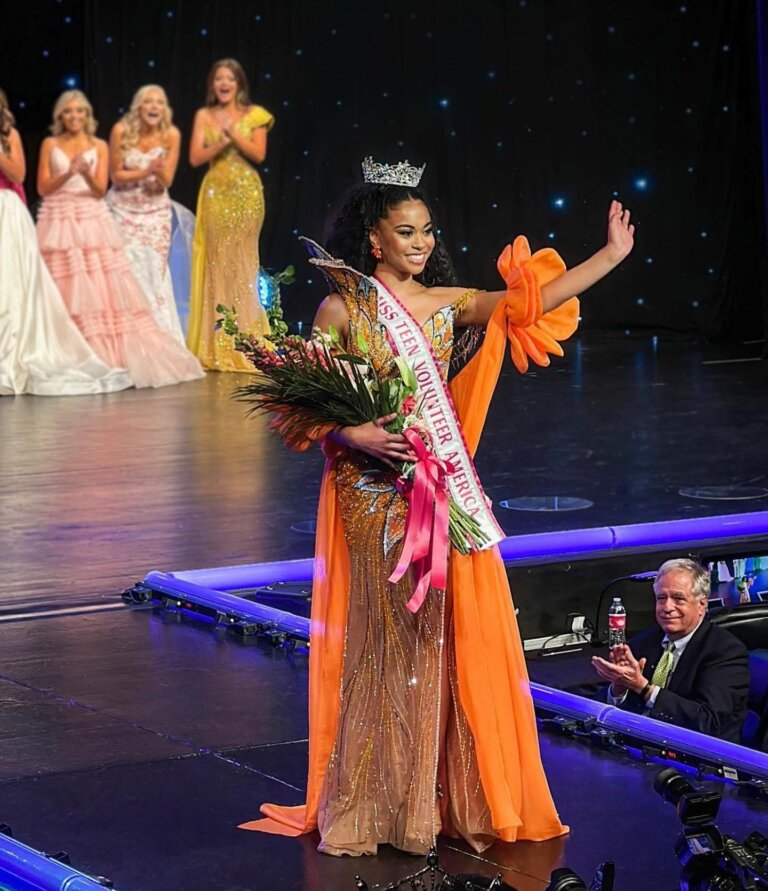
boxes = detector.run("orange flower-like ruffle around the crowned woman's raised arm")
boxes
[494,235,579,374]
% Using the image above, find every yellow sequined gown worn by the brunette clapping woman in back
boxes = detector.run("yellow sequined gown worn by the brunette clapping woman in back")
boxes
[187,105,274,372]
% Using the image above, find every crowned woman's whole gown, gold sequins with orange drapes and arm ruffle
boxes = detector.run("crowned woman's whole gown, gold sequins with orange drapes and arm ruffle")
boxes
[242,239,578,855]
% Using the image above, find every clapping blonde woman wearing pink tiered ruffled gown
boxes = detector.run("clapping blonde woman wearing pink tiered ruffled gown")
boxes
[37,90,204,387]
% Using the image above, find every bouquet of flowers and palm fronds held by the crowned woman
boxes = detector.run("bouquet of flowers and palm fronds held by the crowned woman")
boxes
[216,305,488,556]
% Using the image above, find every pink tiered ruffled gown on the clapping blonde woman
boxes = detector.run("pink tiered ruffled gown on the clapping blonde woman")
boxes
[37,146,205,387]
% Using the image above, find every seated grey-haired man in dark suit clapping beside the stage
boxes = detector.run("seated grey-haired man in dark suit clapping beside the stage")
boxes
[592,559,749,743]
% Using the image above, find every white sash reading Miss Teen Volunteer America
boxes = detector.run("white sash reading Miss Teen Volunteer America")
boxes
[369,278,504,550]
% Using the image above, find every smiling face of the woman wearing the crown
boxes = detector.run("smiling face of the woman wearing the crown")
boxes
[369,201,435,278]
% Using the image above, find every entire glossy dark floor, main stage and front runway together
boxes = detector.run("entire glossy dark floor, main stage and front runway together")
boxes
[0,336,768,891]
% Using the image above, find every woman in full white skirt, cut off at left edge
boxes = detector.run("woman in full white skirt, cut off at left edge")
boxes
[0,90,133,396]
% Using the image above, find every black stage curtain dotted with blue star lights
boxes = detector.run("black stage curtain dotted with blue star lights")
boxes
[0,0,764,338]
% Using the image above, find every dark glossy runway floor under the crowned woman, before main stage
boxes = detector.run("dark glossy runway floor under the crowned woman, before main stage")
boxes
[0,608,768,891]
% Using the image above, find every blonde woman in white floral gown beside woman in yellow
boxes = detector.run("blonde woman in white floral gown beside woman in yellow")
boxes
[107,84,184,343]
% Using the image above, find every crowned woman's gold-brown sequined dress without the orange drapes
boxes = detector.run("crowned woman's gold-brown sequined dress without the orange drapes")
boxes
[318,292,496,854]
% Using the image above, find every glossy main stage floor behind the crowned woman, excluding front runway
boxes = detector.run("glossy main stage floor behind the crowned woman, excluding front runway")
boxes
[0,334,768,610]
